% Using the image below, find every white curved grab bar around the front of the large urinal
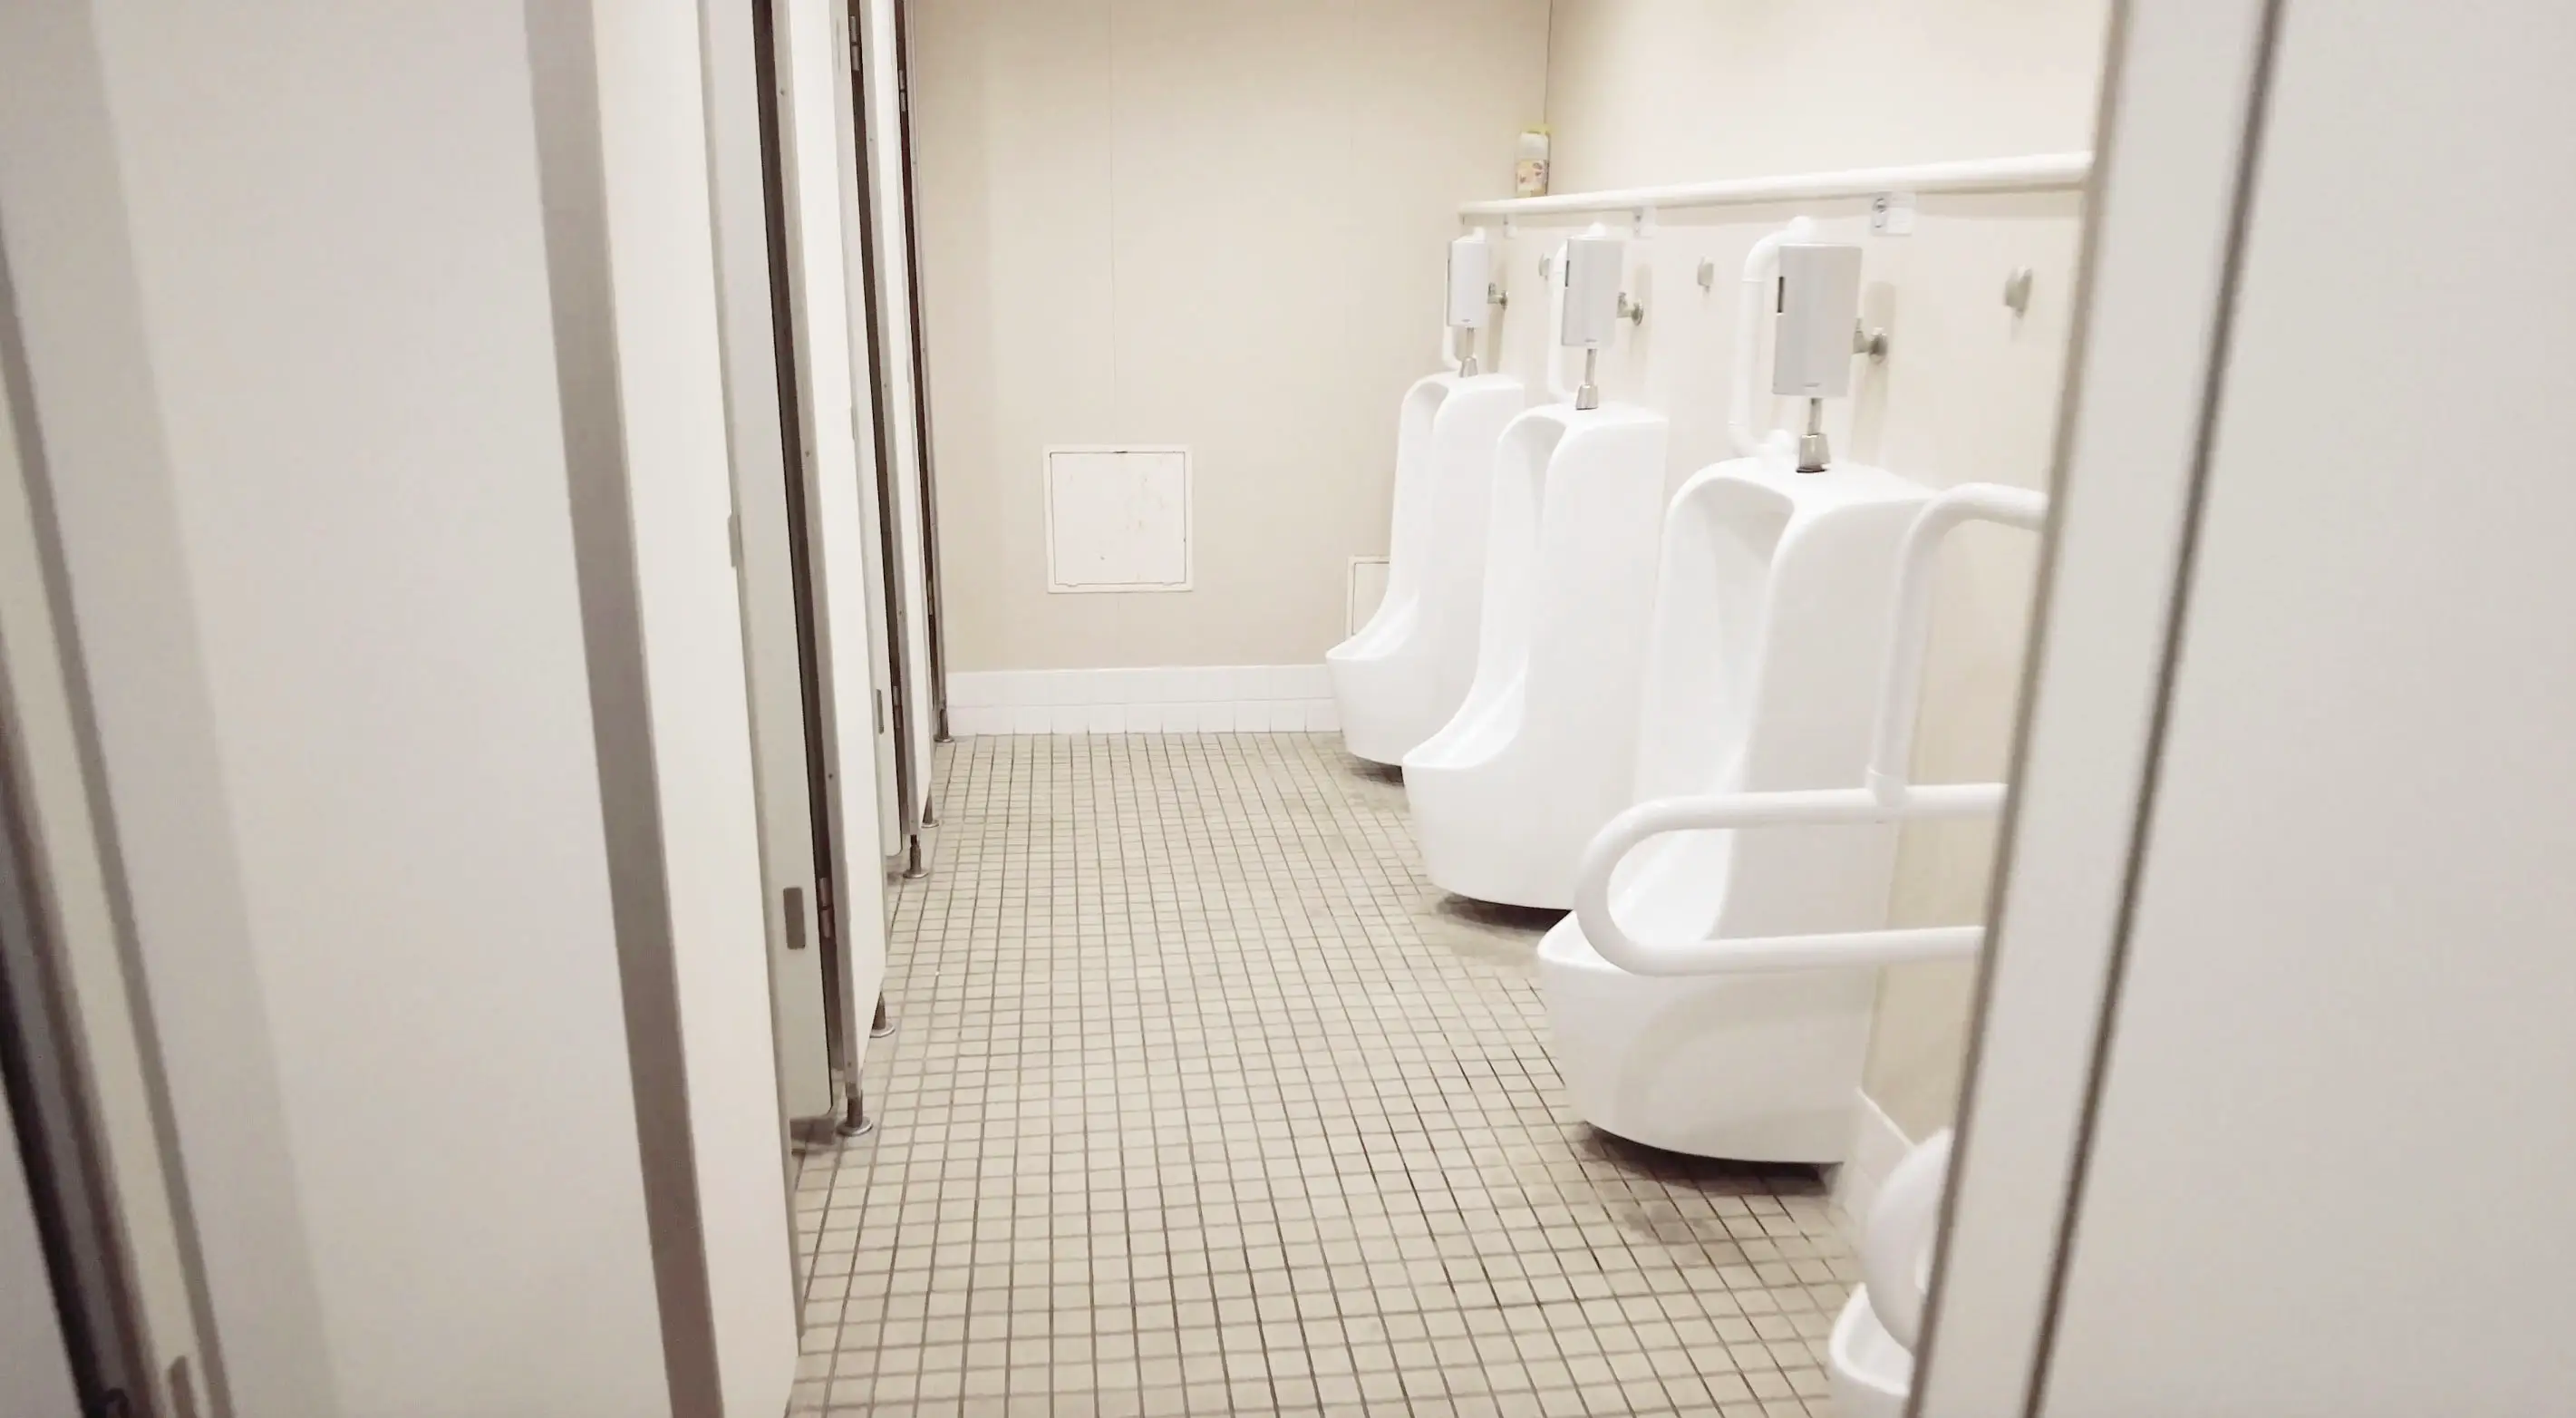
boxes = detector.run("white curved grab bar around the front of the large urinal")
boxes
[1574,482,2048,975]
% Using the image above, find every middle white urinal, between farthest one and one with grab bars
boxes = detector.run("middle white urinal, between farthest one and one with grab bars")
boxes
[1404,404,1670,908]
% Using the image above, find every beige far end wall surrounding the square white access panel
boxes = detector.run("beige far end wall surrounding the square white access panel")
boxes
[912,0,1548,670]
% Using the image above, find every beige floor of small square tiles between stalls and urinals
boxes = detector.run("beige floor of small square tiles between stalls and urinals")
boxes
[796,734,1850,1418]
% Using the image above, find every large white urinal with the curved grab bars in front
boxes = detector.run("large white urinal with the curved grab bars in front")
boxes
[1538,459,1930,1162]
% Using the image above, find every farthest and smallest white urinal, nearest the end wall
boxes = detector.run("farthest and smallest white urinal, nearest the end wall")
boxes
[1324,374,1530,763]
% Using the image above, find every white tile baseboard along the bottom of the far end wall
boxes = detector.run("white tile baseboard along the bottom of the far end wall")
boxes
[948,665,1342,737]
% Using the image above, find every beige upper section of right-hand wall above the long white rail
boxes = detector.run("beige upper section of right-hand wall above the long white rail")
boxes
[1548,0,2110,190]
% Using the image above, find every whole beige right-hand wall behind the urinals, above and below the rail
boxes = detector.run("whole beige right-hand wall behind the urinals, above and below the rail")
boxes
[1515,0,2110,1137]
